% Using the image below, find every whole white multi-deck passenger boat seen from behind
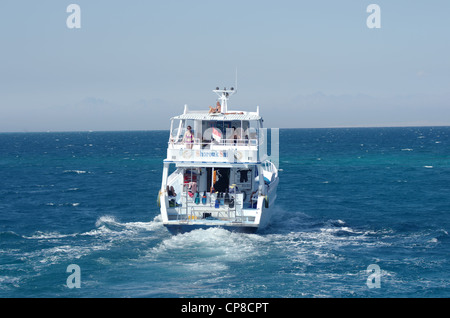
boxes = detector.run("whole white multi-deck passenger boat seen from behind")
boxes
[158,87,279,234]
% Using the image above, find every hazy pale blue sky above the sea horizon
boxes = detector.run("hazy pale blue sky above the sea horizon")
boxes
[0,0,450,131]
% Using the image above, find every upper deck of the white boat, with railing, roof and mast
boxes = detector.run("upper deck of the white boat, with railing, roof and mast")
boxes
[164,89,267,166]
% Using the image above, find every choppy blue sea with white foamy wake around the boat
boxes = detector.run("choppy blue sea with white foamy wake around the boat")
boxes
[0,127,450,298]
